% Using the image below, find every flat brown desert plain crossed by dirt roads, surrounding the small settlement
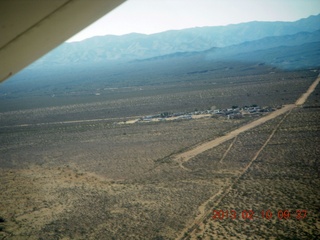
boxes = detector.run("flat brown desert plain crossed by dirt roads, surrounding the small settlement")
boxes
[0,67,320,239]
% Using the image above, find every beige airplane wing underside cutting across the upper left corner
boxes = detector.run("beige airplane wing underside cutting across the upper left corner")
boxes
[0,0,125,82]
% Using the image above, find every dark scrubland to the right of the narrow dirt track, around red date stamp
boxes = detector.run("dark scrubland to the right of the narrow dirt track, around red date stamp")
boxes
[201,109,320,239]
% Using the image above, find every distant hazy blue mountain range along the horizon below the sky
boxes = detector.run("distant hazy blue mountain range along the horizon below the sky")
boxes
[33,14,320,66]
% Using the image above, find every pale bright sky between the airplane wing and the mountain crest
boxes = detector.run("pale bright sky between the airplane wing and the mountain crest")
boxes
[68,0,320,42]
